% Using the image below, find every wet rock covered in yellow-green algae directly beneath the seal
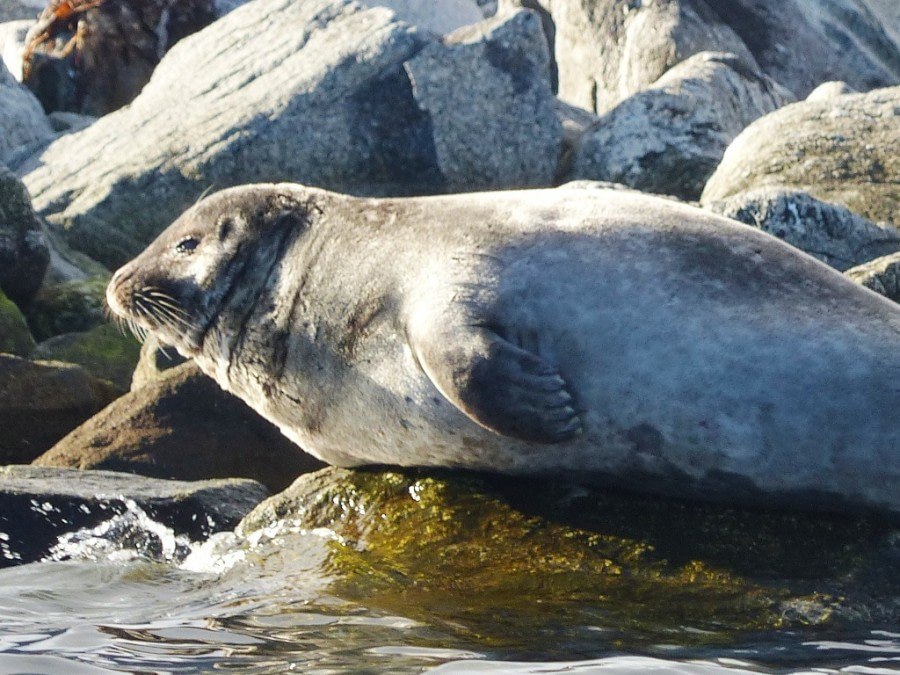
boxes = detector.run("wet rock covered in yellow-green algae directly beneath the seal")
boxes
[239,469,900,650]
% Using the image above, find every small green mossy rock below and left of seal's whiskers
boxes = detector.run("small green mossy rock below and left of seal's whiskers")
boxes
[35,323,141,393]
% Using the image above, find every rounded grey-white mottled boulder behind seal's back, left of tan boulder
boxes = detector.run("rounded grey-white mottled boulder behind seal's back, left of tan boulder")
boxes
[571,52,793,200]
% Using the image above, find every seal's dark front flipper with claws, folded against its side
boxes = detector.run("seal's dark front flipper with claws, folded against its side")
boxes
[413,328,582,443]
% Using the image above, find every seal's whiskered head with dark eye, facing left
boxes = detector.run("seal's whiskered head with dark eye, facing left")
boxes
[106,185,312,356]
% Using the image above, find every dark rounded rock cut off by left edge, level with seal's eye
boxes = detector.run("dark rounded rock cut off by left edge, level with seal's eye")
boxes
[0,164,50,305]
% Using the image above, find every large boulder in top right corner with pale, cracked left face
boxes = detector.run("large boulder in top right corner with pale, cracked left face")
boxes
[541,0,900,113]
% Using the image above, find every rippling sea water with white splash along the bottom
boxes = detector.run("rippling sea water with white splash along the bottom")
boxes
[0,505,900,675]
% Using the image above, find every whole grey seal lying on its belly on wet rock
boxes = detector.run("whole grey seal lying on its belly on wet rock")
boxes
[107,184,900,513]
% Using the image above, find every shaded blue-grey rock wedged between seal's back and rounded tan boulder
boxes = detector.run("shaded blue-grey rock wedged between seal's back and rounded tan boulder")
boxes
[708,188,900,271]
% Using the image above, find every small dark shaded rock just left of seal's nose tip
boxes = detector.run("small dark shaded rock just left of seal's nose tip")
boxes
[24,276,109,342]
